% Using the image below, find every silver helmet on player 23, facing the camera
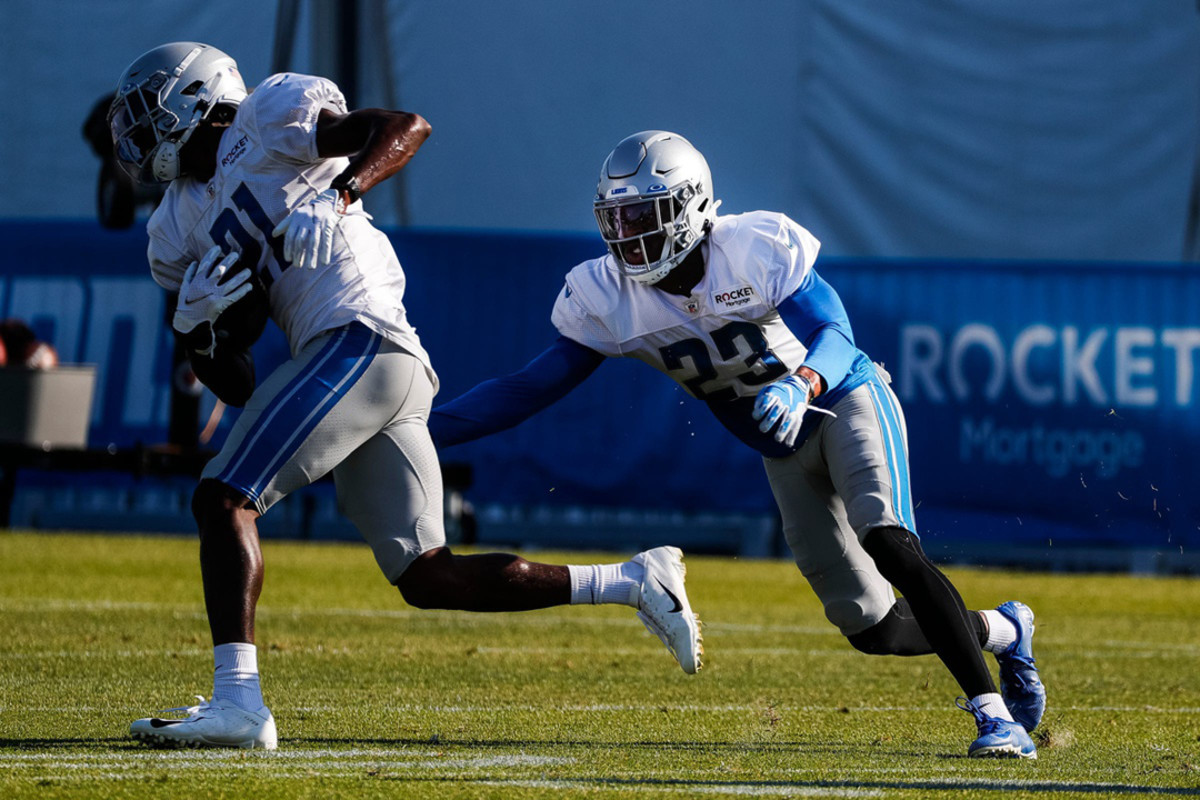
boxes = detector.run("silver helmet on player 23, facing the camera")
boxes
[594,131,720,283]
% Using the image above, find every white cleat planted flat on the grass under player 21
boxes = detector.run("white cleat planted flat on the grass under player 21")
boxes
[130,696,278,750]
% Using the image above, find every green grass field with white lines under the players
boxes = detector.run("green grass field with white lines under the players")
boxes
[0,531,1200,800]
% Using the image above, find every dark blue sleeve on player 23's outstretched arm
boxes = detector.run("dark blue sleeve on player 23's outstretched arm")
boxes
[430,336,606,447]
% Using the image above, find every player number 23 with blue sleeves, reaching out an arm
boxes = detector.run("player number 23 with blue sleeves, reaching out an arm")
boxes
[430,131,1045,758]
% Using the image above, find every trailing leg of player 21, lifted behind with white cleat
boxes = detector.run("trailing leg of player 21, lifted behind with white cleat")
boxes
[334,351,701,673]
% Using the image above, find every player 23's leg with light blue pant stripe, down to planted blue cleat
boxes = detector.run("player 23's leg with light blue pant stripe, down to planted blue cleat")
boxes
[821,375,1037,757]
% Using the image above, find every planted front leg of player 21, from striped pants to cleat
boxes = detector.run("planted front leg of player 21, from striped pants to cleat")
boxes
[131,325,395,748]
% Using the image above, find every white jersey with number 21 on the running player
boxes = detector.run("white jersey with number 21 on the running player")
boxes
[148,73,437,386]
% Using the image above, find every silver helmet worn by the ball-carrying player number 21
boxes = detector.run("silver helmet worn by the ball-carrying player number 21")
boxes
[108,42,246,184]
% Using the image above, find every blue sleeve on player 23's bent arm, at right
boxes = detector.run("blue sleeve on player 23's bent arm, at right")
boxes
[776,270,858,391]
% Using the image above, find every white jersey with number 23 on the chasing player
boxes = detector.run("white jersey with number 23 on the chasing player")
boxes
[551,211,821,402]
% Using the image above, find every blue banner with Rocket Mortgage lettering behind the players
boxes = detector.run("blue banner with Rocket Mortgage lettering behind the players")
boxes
[0,222,1200,548]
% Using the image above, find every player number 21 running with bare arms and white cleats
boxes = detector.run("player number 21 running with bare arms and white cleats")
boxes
[108,42,701,748]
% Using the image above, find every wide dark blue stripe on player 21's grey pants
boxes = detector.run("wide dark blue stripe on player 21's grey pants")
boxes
[216,323,383,503]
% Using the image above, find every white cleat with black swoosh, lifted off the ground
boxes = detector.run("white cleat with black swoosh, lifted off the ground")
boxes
[632,547,704,675]
